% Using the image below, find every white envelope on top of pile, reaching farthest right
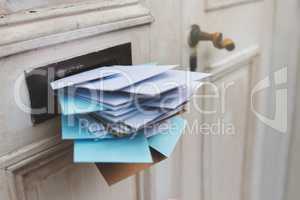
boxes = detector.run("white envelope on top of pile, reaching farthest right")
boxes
[122,70,210,96]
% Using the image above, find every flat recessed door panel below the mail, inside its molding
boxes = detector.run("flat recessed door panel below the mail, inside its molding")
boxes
[24,159,136,200]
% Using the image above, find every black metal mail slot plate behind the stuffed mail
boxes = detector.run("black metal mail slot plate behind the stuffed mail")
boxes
[25,43,132,124]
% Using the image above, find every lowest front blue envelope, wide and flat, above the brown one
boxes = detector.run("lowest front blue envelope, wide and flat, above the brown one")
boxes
[74,134,152,163]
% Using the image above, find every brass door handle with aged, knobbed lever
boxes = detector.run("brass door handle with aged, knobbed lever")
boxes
[189,24,235,51]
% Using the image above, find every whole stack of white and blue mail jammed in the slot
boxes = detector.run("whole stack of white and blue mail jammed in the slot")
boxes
[51,64,209,184]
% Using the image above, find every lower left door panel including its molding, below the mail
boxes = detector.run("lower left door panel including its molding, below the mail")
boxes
[4,137,137,200]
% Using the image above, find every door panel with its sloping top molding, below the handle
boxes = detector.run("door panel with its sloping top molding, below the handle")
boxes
[201,44,261,200]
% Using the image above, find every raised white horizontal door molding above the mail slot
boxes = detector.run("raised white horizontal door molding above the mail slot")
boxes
[0,0,153,57]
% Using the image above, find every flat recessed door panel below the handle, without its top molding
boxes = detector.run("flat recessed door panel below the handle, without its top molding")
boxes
[203,65,251,200]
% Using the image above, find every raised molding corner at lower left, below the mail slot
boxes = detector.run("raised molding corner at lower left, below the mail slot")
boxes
[0,137,73,200]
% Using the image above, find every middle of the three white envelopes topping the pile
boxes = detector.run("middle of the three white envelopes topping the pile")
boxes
[76,64,177,91]
